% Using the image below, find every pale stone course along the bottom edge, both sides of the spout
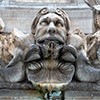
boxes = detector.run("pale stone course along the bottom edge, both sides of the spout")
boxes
[0,89,100,100]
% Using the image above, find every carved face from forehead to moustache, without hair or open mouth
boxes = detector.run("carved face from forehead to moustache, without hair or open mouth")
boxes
[35,13,67,42]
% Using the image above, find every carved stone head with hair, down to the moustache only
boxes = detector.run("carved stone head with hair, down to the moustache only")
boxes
[31,8,69,42]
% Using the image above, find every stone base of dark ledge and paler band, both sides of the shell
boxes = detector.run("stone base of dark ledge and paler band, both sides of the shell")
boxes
[0,82,100,100]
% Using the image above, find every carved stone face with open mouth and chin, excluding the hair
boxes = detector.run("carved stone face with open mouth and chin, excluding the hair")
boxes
[35,13,67,58]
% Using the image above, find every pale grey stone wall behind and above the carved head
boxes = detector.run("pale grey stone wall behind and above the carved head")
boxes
[0,0,95,34]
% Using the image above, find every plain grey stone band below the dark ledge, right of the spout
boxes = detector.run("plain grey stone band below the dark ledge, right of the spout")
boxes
[65,91,100,100]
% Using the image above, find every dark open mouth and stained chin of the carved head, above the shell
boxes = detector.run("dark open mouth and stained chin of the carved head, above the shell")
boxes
[36,37,64,59]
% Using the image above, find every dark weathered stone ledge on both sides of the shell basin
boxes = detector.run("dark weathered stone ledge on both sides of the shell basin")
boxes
[0,82,100,91]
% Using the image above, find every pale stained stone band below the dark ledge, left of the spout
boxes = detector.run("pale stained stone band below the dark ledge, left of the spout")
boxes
[0,89,43,100]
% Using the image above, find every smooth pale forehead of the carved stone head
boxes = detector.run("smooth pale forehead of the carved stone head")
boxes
[40,13,64,21]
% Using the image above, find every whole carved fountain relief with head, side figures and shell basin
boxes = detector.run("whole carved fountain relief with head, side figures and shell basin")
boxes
[0,8,100,94]
